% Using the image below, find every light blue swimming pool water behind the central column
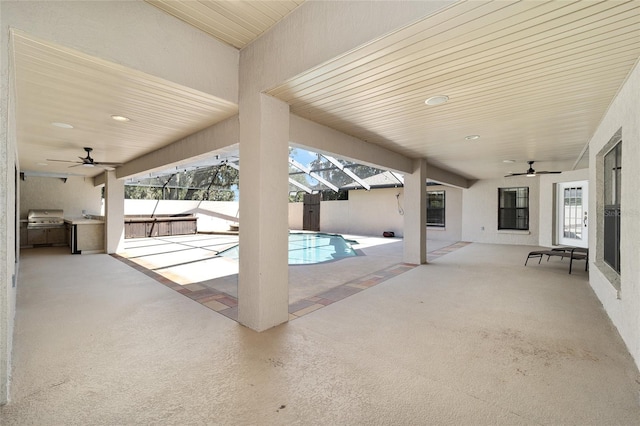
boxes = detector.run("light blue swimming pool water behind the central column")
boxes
[219,232,358,265]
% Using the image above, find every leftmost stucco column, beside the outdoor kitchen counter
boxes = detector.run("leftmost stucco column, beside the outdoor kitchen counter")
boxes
[104,171,124,253]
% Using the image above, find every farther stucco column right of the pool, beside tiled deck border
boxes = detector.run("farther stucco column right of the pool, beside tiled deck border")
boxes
[404,159,427,265]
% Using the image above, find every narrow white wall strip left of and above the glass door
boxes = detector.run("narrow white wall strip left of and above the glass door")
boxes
[538,169,589,247]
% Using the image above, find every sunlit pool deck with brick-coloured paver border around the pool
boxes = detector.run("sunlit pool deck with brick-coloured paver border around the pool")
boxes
[114,234,467,321]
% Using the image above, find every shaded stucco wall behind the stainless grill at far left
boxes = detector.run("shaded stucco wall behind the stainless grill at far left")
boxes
[20,176,102,219]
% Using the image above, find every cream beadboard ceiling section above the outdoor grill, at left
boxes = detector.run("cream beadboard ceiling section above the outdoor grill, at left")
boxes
[12,30,238,176]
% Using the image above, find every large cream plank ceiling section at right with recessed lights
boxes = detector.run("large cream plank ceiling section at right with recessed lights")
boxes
[268,1,640,179]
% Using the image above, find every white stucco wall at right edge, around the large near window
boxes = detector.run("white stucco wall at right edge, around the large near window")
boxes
[589,60,640,366]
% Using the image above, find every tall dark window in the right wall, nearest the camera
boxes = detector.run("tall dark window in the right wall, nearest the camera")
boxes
[604,142,622,273]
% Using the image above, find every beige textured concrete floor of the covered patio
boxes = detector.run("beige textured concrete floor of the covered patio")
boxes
[0,243,640,425]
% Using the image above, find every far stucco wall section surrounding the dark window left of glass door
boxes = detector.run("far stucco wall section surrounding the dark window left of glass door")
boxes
[462,177,540,246]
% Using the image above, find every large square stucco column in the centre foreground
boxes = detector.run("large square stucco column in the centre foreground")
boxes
[238,94,289,331]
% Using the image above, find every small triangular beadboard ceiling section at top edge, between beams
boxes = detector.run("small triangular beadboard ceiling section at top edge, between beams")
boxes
[145,0,304,49]
